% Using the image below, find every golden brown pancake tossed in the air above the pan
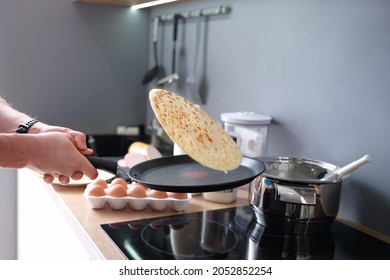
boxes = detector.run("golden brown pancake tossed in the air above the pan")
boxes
[149,89,242,172]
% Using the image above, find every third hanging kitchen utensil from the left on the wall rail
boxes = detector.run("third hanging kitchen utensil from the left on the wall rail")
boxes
[186,13,205,104]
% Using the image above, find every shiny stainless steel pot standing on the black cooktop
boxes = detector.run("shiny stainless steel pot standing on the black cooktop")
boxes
[249,157,343,235]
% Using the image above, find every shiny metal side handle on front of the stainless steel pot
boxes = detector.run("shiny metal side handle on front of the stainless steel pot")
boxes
[275,184,317,205]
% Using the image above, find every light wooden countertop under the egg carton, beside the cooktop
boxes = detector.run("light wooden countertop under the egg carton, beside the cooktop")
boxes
[41,173,248,260]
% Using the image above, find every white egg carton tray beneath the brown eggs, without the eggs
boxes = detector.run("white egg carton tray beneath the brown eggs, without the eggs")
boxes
[84,194,192,212]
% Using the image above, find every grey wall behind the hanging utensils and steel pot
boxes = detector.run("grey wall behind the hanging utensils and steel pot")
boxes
[150,0,390,235]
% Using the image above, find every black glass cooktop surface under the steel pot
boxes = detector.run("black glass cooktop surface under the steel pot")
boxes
[101,206,390,260]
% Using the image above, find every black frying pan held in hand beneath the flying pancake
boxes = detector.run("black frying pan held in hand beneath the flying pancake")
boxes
[87,155,265,193]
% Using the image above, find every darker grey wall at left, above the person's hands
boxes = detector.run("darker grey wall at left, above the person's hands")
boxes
[0,0,149,133]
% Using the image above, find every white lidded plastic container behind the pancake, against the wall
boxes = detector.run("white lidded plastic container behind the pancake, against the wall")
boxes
[221,112,272,158]
